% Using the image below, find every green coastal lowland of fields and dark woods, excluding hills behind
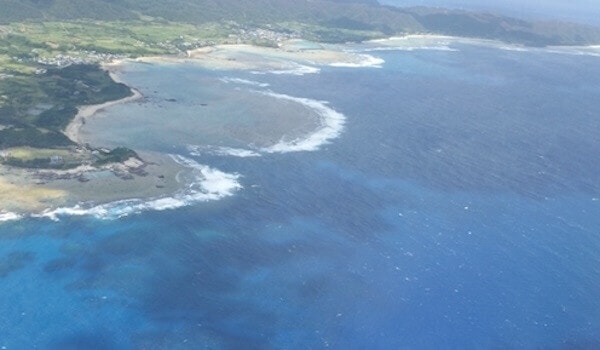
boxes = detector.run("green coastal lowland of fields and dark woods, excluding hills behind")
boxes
[0,19,383,167]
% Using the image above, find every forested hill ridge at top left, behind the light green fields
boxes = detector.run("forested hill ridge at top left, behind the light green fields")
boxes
[0,0,379,23]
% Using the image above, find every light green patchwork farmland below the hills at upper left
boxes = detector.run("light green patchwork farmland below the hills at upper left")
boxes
[5,20,239,58]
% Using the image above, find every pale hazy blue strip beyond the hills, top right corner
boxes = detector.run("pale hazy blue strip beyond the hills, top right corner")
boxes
[379,0,600,26]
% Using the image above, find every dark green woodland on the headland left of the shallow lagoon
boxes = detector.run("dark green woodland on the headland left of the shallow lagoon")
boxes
[0,65,131,168]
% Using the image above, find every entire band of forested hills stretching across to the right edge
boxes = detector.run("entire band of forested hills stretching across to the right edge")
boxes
[0,0,600,46]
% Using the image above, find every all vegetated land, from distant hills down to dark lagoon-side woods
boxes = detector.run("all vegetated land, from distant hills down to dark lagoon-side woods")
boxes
[0,0,600,168]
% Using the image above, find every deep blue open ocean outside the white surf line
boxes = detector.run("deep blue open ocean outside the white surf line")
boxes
[0,45,600,349]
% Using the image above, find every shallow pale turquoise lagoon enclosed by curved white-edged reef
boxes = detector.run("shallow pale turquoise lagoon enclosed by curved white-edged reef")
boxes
[82,63,328,152]
